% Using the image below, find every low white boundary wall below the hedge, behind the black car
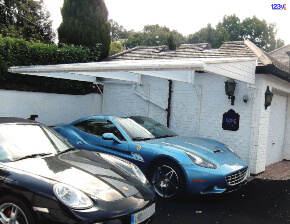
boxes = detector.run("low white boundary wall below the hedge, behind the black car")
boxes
[0,90,102,125]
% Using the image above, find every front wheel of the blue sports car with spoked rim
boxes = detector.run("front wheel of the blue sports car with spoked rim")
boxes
[149,160,186,200]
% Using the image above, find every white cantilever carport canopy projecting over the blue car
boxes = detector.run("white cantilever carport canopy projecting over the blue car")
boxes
[8,58,256,84]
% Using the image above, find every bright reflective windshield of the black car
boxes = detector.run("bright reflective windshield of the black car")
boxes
[0,124,73,162]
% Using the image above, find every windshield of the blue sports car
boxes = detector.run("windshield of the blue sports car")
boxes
[115,116,177,141]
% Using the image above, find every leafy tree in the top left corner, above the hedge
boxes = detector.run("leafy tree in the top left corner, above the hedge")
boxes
[0,0,55,43]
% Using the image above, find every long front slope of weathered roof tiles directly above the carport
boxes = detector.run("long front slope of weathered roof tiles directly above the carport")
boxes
[106,41,256,61]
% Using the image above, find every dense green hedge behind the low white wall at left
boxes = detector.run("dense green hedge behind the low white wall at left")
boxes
[0,35,98,94]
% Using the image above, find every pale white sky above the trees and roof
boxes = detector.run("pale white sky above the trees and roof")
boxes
[44,0,290,44]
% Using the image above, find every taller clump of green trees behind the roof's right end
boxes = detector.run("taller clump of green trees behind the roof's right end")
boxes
[187,14,284,52]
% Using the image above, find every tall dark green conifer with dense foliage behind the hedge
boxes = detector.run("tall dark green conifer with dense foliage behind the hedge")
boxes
[58,0,111,59]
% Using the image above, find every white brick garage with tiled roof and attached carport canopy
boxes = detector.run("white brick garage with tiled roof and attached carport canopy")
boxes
[10,41,290,174]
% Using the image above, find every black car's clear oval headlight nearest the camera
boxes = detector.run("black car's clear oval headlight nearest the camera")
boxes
[53,183,93,209]
